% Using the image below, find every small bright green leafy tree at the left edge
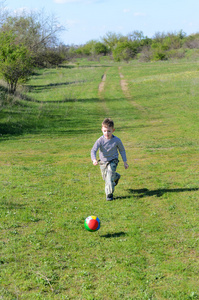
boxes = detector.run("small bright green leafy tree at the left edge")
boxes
[0,31,33,93]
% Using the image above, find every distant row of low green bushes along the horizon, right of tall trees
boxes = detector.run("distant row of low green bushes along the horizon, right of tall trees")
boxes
[69,30,199,62]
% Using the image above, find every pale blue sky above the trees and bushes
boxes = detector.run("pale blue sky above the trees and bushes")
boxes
[4,0,199,45]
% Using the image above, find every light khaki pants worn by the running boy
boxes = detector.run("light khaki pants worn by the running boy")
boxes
[99,159,120,195]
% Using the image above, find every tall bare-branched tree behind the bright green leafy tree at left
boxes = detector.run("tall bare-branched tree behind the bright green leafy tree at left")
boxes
[0,11,64,67]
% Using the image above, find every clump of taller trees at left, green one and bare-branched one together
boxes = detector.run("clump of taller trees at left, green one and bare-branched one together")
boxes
[0,1,68,93]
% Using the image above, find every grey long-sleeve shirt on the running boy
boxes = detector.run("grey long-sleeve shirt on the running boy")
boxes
[91,135,127,162]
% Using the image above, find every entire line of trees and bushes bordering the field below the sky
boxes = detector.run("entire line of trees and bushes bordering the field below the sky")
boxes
[0,1,199,93]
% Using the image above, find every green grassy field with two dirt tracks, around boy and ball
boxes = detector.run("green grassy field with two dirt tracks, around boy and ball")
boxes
[0,57,199,300]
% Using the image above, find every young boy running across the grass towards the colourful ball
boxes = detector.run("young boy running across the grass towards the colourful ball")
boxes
[91,118,129,201]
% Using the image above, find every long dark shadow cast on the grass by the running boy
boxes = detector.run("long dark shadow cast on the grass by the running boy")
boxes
[114,188,199,200]
